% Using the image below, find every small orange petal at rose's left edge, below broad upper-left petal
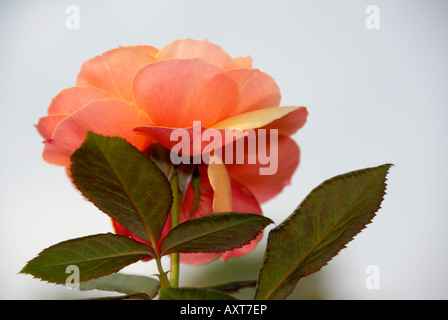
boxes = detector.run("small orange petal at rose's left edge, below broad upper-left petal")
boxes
[48,87,112,115]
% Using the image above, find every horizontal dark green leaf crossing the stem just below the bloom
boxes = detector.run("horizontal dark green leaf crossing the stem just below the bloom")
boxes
[160,212,272,255]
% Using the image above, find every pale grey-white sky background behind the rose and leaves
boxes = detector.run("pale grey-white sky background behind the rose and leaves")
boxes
[0,0,448,299]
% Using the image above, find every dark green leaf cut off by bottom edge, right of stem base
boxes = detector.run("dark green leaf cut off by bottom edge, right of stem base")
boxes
[160,288,236,300]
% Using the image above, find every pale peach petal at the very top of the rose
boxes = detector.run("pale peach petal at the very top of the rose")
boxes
[156,39,237,69]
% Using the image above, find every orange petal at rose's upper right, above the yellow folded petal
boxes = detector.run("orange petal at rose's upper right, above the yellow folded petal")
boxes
[227,69,281,114]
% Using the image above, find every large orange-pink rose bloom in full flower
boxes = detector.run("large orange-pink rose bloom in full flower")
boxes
[36,39,307,264]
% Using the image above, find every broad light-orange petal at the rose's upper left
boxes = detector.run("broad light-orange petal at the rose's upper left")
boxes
[76,47,156,101]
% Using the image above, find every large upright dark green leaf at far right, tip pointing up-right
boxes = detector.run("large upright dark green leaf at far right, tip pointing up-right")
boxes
[255,164,391,300]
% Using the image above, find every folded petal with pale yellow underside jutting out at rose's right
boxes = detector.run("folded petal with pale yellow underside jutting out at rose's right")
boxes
[211,107,308,135]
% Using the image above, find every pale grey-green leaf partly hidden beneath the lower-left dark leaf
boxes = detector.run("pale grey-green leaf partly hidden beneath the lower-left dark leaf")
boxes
[79,273,160,299]
